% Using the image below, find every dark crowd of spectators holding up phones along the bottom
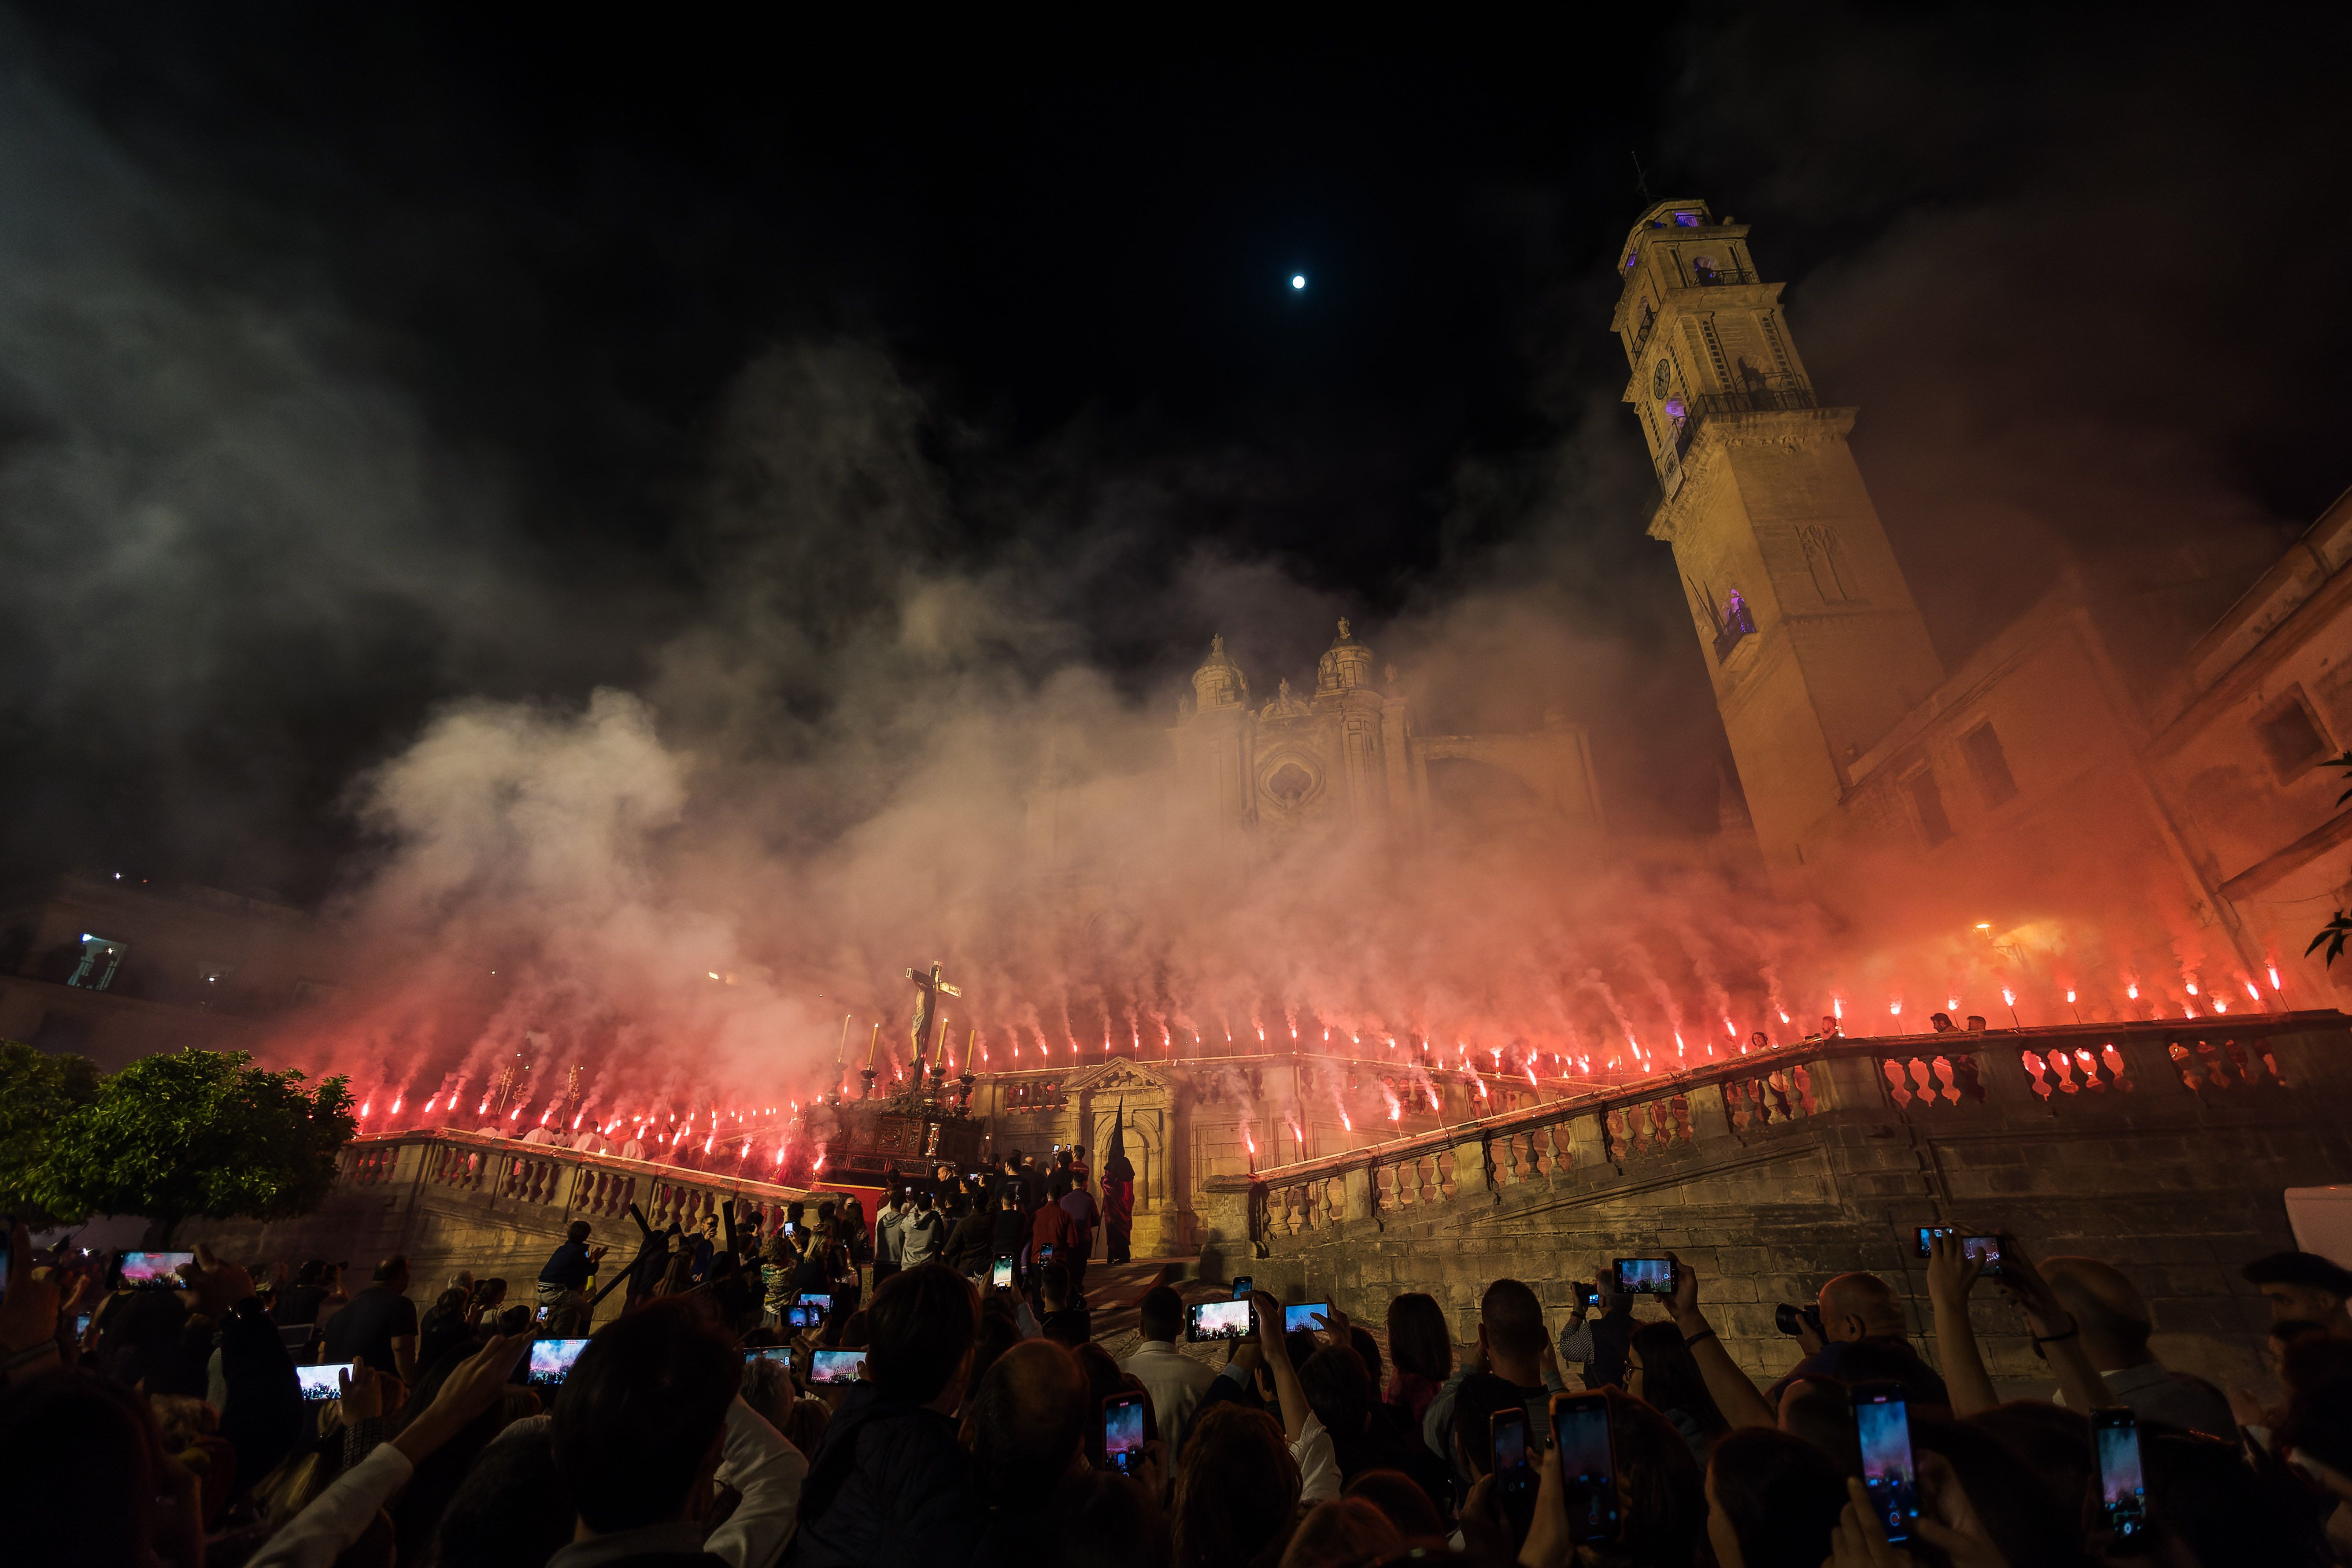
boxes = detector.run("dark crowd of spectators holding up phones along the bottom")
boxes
[0,1175,2352,1568]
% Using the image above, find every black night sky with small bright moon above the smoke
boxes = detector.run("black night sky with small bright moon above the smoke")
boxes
[0,5,2352,900]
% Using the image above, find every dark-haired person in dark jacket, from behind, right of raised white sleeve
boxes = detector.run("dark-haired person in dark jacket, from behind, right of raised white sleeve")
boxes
[783,1262,985,1568]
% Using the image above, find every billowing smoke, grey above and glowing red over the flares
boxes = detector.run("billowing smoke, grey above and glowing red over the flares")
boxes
[0,6,2347,1154]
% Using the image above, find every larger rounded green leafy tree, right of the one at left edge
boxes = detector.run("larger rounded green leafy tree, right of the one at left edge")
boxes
[33,1051,358,1241]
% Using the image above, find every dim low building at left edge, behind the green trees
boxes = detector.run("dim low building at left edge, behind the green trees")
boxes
[0,872,334,1069]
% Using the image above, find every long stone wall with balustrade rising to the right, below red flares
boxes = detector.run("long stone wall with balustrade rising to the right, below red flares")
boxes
[1202,1013,2352,1389]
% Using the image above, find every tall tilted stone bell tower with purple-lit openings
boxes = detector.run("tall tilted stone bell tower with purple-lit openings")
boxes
[1611,200,1943,865]
